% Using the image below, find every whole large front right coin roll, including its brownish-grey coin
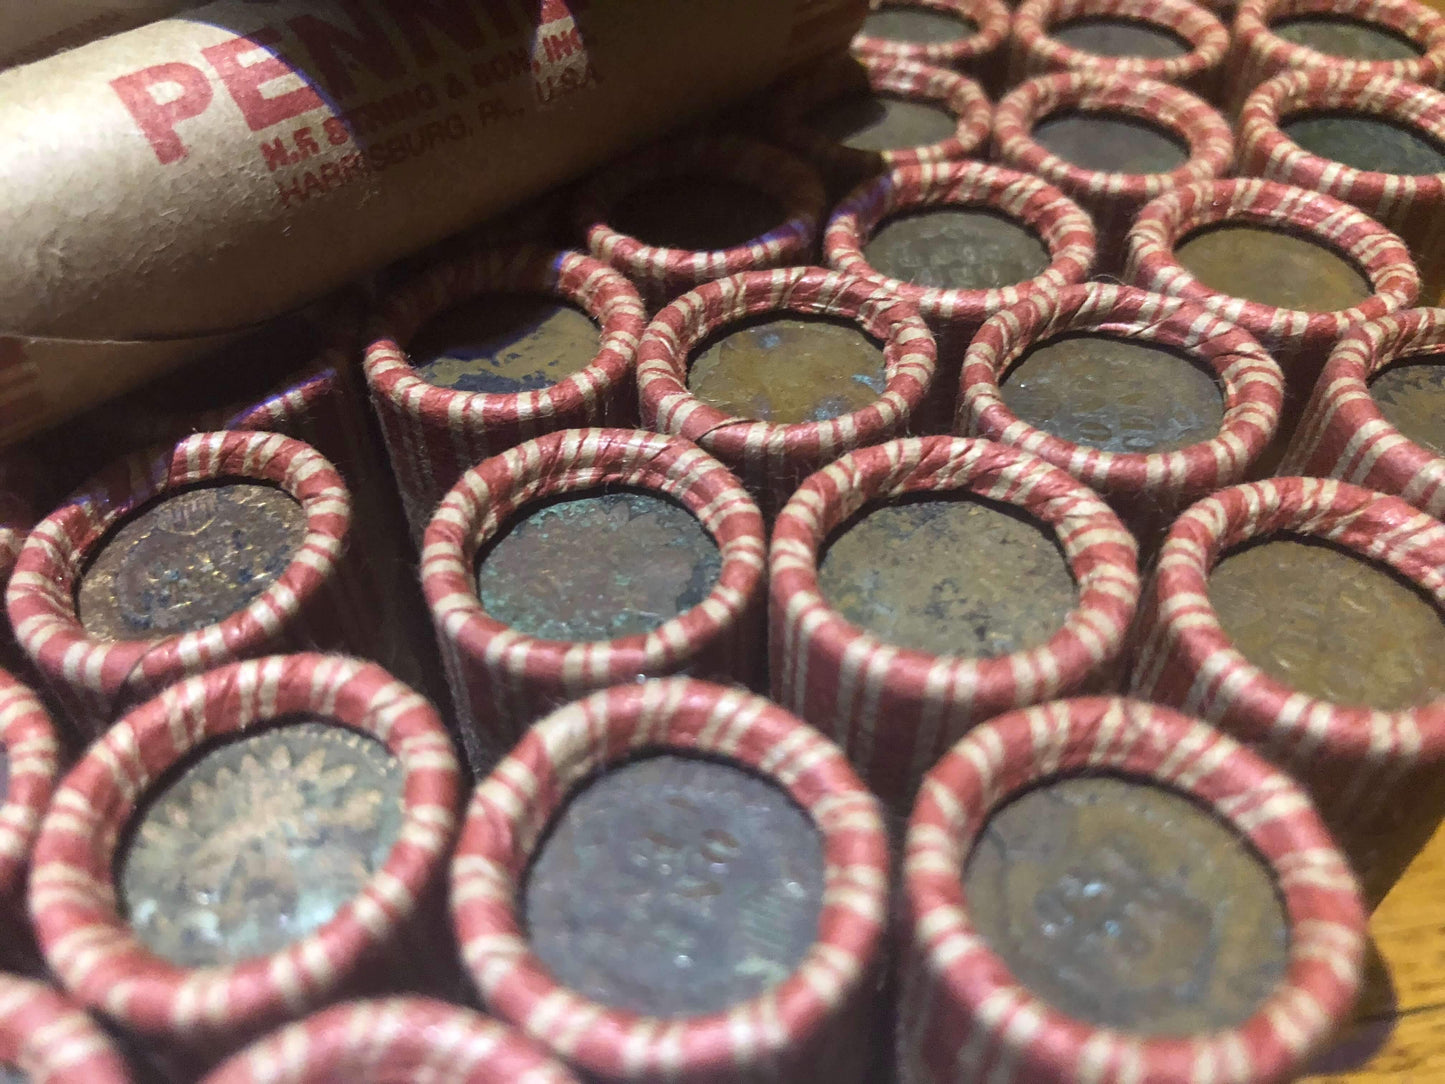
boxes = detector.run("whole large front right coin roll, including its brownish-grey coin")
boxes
[899,698,1366,1084]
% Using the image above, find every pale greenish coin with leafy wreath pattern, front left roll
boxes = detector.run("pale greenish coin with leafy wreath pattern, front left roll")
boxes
[117,718,405,967]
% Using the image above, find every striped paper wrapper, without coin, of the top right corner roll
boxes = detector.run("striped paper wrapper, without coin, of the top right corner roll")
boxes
[1225,0,1445,111]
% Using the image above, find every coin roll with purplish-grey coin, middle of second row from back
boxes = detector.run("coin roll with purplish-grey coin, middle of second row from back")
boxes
[993,71,1234,273]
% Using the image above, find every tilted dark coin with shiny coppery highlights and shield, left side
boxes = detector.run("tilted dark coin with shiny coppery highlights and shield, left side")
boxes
[75,481,306,640]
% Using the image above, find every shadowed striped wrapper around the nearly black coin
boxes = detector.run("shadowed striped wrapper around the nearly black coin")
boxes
[575,137,827,308]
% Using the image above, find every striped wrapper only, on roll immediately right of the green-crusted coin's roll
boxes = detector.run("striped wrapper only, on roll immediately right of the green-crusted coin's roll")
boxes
[767,436,1139,811]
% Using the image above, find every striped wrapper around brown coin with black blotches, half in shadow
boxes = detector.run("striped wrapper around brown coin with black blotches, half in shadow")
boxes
[363,247,647,542]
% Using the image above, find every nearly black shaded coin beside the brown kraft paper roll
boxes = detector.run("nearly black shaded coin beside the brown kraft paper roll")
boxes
[608,176,788,251]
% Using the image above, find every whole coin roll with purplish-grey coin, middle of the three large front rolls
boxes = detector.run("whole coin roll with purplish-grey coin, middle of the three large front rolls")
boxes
[451,678,889,1081]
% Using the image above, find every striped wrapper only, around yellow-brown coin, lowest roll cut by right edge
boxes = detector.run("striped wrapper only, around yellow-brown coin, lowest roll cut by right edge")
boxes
[1131,478,1445,899]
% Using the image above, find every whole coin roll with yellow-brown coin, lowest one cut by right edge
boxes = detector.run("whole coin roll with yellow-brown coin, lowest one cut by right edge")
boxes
[1130,477,1445,900]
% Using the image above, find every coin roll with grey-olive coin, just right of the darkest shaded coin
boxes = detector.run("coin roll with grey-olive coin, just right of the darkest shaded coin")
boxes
[824,162,1094,434]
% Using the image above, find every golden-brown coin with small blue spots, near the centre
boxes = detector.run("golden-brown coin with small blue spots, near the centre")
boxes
[688,317,887,425]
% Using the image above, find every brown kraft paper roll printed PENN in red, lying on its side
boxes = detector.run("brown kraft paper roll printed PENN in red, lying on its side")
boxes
[0,0,866,442]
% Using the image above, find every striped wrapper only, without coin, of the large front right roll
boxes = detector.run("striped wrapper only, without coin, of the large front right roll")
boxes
[899,697,1366,1084]
